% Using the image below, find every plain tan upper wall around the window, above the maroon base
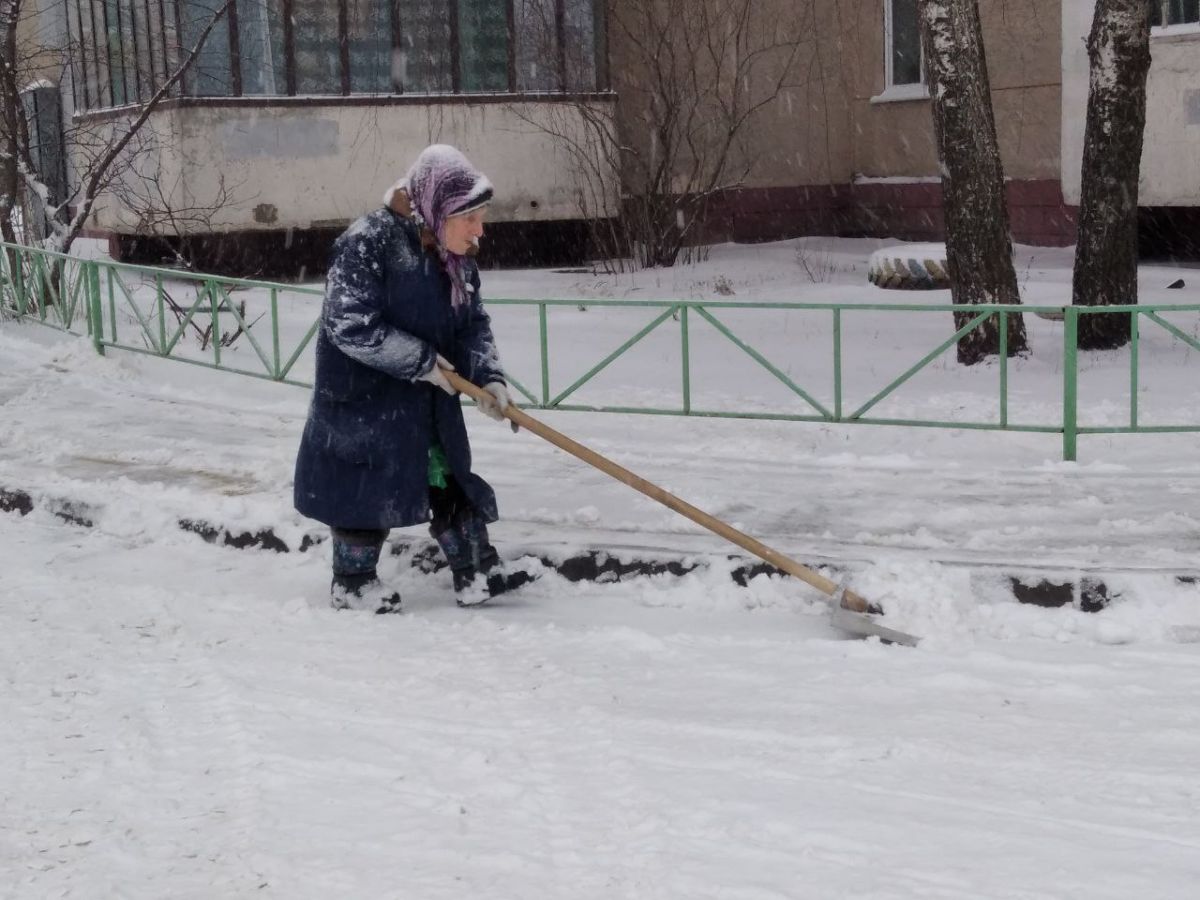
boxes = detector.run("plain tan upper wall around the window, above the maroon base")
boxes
[612,0,1062,187]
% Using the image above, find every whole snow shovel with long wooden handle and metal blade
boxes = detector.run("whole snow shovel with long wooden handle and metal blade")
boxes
[443,370,919,647]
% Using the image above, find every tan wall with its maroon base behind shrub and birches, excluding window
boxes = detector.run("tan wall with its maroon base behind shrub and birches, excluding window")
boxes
[610,0,1072,244]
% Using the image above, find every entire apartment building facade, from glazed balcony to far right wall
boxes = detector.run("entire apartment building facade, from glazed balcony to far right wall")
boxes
[28,0,1200,270]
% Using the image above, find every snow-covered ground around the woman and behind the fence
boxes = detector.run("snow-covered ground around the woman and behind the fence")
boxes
[0,240,1200,900]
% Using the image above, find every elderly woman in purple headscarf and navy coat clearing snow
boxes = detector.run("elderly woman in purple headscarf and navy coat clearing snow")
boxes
[295,145,509,612]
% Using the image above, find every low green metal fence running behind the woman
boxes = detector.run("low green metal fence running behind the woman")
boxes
[0,244,1200,461]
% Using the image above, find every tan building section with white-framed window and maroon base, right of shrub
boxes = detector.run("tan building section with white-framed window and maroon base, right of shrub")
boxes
[691,0,1074,245]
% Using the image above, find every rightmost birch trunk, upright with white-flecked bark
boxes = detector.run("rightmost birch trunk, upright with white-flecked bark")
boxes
[1070,0,1151,350]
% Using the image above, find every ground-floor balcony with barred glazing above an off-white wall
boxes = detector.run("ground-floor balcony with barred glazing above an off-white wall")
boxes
[56,0,617,270]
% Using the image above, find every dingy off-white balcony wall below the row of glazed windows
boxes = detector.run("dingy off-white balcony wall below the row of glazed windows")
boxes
[92,101,616,233]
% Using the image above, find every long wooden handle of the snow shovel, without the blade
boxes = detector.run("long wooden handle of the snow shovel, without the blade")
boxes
[443,371,870,612]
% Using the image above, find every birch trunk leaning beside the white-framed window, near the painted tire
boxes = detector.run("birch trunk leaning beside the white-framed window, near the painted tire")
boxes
[918,0,1028,366]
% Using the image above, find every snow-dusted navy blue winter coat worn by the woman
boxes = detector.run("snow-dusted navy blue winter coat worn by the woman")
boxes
[295,209,504,528]
